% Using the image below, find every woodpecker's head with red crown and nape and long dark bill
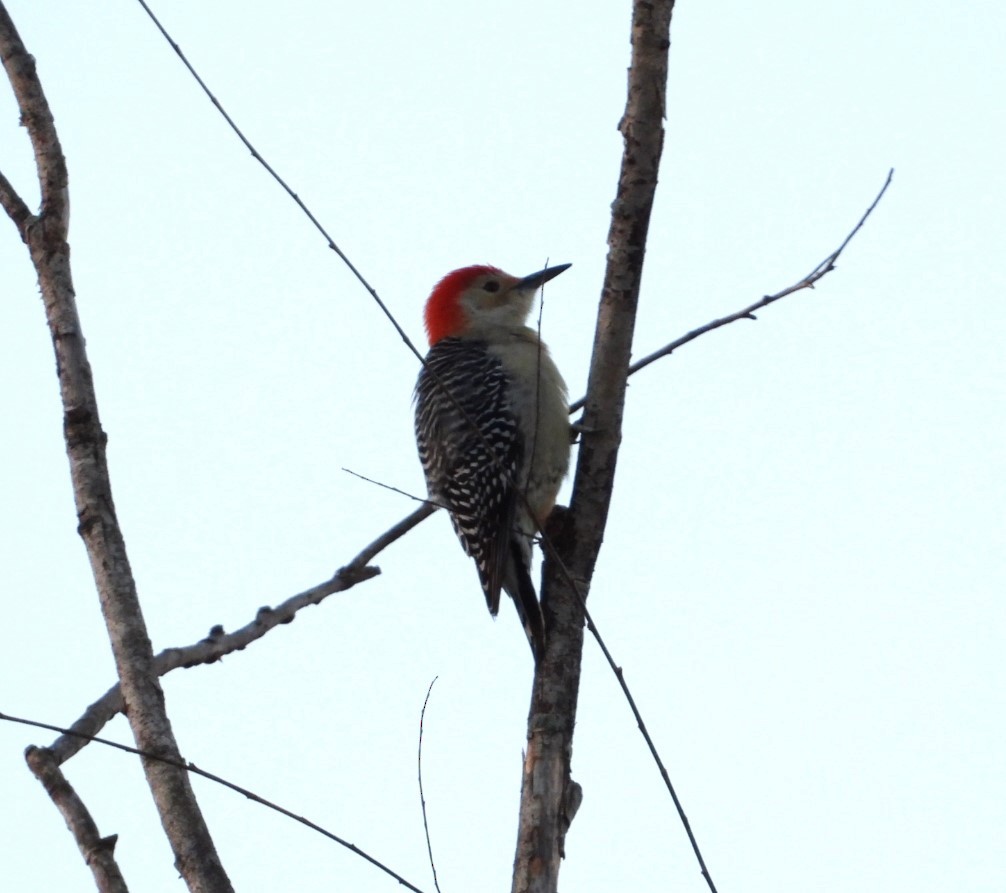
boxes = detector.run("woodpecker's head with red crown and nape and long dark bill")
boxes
[424,263,570,347]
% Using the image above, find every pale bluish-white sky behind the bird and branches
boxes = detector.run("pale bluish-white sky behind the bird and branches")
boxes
[0,0,1006,893]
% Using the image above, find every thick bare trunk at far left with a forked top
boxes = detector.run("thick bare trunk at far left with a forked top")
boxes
[0,2,231,893]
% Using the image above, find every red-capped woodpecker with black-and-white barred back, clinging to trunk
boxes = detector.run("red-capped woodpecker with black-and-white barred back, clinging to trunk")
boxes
[415,263,570,661]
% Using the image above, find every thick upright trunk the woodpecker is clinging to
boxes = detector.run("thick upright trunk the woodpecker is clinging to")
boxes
[512,0,674,893]
